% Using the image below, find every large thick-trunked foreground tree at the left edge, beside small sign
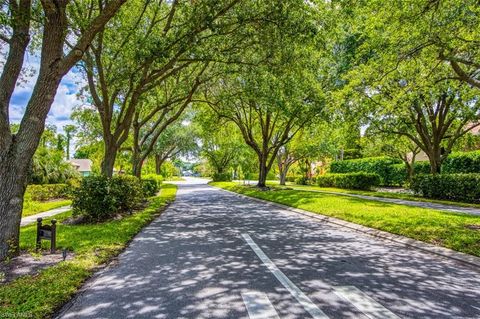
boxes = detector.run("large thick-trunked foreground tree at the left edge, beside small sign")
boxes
[0,0,126,259]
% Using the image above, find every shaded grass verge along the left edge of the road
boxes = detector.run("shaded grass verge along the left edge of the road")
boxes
[0,184,177,318]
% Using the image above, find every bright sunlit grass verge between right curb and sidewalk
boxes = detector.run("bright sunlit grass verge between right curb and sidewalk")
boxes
[210,182,480,256]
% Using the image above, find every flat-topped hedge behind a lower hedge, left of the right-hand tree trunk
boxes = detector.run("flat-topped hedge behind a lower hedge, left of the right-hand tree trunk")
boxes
[330,157,403,186]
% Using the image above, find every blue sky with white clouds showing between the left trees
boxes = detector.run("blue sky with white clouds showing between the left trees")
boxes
[9,53,85,133]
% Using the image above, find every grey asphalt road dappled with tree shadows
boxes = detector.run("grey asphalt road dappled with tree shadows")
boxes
[60,180,480,319]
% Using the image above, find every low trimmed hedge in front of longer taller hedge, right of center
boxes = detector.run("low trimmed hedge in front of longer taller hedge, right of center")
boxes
[317,172,380,190]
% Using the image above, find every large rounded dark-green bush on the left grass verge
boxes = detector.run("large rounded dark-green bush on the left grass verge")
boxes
[72,175,143,221]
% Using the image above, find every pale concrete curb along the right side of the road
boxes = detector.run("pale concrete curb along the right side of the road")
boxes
[212,186,480,268]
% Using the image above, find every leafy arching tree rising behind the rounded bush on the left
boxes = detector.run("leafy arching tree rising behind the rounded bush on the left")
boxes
[83,0,267,176]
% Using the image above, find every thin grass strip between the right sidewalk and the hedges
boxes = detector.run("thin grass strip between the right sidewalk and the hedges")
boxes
[260,181,480,208]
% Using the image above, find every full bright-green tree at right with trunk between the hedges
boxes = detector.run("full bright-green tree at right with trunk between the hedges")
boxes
[343,0,480,174]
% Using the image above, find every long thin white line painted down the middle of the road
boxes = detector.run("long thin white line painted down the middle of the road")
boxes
[242,234,328,319]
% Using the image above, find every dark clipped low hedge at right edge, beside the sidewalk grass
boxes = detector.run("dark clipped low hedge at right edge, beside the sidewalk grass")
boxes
[410,174,480,203]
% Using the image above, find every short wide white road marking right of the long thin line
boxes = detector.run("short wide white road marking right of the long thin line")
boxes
[333,286,400,319]
